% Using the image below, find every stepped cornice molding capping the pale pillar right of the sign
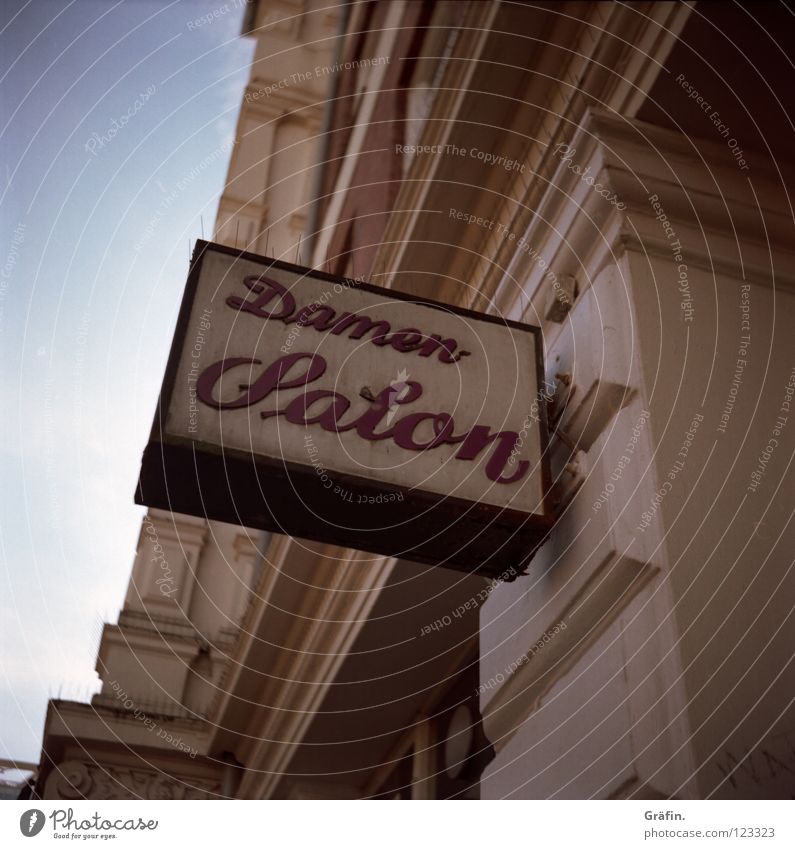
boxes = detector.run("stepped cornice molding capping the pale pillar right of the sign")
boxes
[496,110,795,324]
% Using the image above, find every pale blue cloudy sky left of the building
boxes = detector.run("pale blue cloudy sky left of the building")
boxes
[0,0,254,762]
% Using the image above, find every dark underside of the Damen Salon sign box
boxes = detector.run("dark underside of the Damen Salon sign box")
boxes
[135,441,551,580]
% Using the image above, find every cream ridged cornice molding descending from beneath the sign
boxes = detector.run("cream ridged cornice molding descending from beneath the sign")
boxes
[208,535,396,798]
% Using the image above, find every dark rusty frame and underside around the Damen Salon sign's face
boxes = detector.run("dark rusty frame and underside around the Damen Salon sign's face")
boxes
[135,240,554,580]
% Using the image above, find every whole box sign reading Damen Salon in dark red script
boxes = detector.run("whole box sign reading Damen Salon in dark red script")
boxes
[136,242,550,575]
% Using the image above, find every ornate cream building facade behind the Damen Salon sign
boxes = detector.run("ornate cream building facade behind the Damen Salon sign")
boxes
[35,0,795,799]
